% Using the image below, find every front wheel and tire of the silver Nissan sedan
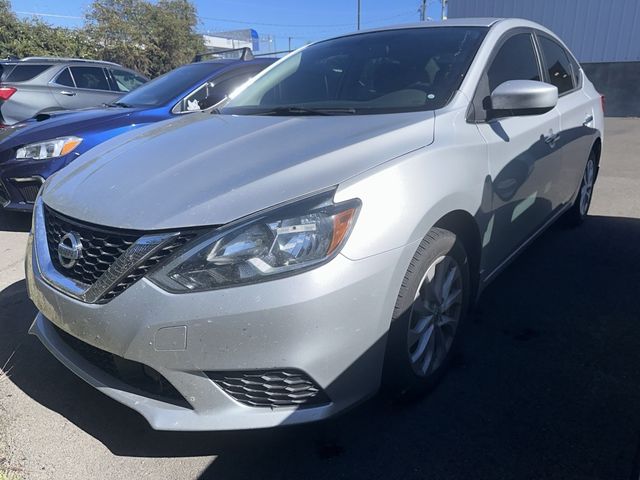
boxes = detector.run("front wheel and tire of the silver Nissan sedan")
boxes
[383,228,471,397]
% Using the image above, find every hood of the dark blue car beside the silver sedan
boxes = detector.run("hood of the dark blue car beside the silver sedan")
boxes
[0,108,139,151]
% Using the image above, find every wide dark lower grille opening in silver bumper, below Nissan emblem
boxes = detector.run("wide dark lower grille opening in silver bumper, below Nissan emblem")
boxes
[51,323,192,408]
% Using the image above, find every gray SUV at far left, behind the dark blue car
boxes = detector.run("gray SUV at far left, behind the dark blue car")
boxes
[0,57,147,125]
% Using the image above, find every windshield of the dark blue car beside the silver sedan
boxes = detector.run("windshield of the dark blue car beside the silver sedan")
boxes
[118,63,223,107]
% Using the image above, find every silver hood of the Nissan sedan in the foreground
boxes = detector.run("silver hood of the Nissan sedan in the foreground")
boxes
[43,112,434,230]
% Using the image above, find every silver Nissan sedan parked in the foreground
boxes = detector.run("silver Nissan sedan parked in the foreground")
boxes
[27,19,603,430]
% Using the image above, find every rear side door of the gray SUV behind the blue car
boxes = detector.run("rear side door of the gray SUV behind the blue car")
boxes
[50,66,122,110]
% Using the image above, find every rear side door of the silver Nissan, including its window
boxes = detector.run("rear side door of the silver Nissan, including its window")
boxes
[536,32,597,203]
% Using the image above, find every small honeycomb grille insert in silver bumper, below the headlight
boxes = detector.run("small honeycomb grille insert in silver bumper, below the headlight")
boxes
[207,369,329,407]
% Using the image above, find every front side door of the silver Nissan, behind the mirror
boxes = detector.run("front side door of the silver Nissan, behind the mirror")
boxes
[473,29,560,271]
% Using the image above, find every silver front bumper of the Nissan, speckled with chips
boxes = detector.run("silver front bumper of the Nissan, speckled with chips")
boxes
[26,229,415,430]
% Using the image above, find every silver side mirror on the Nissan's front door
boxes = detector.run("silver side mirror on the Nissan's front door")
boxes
[491,80,558,118]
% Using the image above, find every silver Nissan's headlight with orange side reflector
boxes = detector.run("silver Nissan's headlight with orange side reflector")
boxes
[150,191,360,293]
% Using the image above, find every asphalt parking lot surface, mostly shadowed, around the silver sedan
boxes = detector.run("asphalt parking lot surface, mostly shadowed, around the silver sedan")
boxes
[0,119,640,480]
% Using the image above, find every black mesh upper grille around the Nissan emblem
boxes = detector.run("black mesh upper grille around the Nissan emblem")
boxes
[45,207,198,302]
